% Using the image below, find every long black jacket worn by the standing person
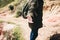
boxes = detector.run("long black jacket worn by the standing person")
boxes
[23,0,43,28]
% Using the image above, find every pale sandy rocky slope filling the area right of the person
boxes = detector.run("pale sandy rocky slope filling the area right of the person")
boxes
[36,0,60,40]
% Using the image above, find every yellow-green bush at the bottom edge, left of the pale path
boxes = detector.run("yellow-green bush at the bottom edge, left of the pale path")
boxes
[13,27,24,40]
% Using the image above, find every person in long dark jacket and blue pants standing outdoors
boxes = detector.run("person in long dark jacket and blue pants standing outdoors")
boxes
[22,0,44,40]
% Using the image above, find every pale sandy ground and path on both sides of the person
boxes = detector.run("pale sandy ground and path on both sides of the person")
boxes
[0,2,60,40]
